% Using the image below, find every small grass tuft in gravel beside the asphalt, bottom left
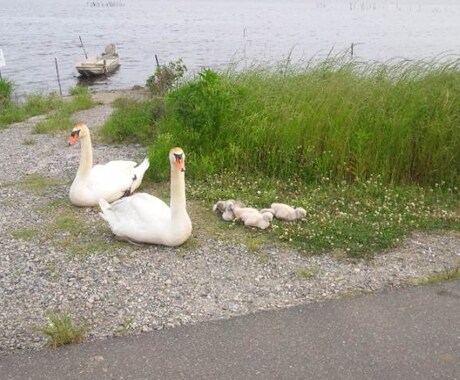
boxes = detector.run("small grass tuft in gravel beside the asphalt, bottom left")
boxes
[38,311,87,348]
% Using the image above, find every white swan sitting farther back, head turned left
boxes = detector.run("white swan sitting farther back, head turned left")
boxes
[68,124,149,206]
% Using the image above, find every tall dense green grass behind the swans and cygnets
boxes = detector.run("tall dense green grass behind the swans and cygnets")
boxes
[150,59,460,185]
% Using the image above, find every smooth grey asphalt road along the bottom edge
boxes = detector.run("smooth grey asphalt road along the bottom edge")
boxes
[0,280,460,380]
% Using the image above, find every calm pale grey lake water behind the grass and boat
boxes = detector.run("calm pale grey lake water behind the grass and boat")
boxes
[0,0,460,94]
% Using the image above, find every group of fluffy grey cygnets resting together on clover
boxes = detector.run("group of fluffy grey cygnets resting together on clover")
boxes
[213,199,307,229]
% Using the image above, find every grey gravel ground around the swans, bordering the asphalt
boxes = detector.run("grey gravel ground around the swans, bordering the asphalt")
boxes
[0,94,460,354]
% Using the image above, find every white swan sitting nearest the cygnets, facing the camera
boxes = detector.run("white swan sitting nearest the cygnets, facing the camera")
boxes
[99,148,192,247]
